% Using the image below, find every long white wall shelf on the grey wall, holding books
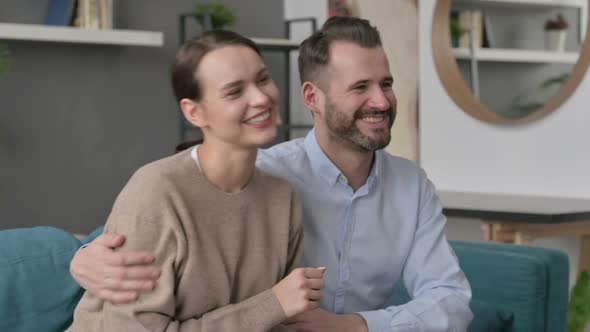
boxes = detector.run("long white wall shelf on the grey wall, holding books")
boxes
[0,23,164,47]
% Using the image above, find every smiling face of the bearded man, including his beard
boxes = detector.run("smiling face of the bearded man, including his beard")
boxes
[320,42,397,152]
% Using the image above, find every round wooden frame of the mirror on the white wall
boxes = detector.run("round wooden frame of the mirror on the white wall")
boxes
[431,0,590,124]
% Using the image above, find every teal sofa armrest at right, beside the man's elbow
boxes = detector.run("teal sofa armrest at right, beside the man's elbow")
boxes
[451,241,569,331]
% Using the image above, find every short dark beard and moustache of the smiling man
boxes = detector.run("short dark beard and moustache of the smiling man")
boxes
[326,101,396,152]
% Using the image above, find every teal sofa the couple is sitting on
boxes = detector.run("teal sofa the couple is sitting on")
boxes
[0,227,569,332]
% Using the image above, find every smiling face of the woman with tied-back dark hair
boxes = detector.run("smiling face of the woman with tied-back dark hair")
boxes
[196,45,280,147]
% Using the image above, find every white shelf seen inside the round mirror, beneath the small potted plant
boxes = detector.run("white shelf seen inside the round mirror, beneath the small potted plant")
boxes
[453,48,578,64]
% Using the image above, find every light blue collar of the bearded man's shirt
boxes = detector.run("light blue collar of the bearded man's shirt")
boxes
[304,129,382,188]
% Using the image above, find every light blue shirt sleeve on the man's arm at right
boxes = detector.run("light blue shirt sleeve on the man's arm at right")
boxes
[359,171,473,332]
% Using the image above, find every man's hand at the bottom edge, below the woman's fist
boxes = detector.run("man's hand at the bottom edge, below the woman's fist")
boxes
[283,308,369,332]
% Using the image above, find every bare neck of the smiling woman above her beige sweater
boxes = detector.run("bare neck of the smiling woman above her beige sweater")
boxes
[197,141,258,193]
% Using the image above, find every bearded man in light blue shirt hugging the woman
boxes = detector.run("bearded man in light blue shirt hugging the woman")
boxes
[72,17,472,331]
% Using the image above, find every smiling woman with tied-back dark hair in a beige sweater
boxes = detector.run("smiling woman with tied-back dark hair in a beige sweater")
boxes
[73,30,323,331]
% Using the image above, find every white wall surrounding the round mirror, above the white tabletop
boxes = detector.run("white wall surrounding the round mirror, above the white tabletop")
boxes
[419,1,590,197]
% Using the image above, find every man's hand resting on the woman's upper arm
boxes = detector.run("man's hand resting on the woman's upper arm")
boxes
[70,233,160,304]
